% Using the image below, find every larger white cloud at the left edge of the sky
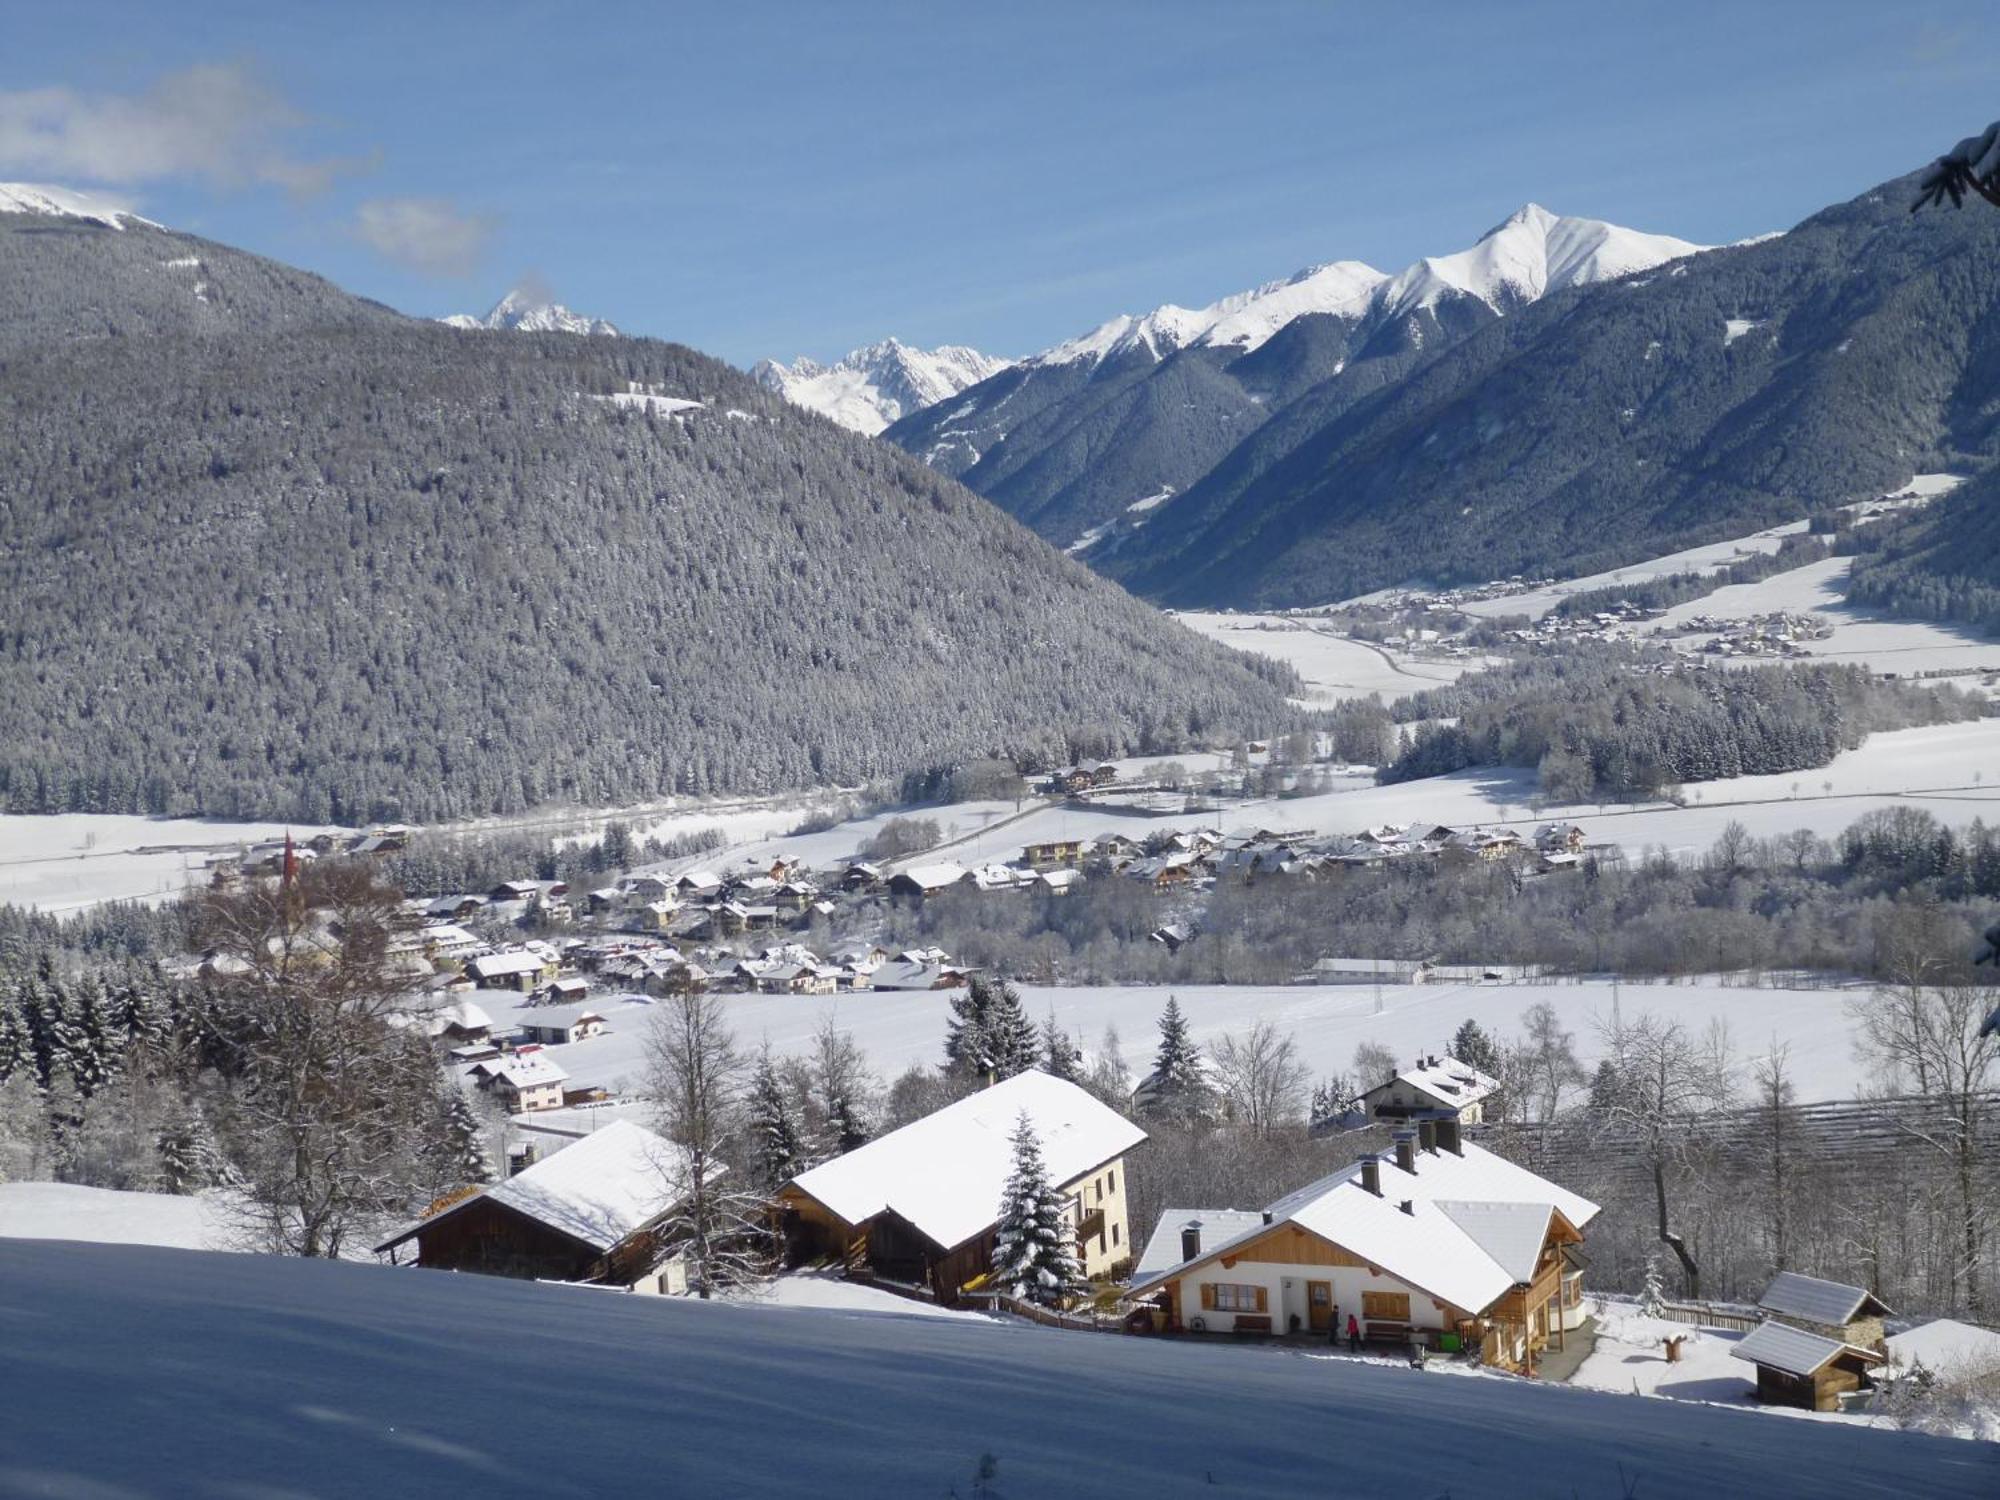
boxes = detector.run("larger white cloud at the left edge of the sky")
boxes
[0,62,360,192]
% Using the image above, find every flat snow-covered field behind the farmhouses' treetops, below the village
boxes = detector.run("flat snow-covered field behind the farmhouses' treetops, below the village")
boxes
[524,978,1868,1104]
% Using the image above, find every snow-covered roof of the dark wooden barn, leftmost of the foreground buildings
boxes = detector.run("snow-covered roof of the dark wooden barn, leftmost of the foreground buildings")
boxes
[376,1120,714,1252]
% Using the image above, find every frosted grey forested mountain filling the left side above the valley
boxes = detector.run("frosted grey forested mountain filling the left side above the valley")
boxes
[0,216,1290,820]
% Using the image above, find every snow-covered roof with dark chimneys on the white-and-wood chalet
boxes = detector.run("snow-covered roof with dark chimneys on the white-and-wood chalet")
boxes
[1132,1144,1598,1312]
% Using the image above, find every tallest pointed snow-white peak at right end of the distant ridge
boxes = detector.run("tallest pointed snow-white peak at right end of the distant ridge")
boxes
[1380,204,1708,316]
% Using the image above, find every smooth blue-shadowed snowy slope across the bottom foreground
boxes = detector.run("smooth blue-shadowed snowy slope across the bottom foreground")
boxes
[0,1242,2000,1500]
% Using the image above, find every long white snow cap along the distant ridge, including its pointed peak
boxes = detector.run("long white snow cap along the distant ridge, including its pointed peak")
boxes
[1026,204,1708,366]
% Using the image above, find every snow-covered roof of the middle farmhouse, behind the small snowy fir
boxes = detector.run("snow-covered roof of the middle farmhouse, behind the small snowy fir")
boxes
[792,1068,1146,1250]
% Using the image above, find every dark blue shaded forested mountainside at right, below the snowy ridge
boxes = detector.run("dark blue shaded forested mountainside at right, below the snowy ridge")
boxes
[1092,170,2000,606]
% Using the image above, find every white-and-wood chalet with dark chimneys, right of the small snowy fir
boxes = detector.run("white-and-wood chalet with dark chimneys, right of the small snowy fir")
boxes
[1126,1120,1598,1370]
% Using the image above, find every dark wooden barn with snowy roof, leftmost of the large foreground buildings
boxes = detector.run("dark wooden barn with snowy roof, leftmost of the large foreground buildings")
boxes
[376,1120,720,1294]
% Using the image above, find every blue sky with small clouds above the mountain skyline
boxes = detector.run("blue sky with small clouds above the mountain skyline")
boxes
[0,0,2000,362]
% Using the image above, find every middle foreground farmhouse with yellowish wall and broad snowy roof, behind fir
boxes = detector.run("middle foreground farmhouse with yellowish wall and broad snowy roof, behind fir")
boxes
[778,1070,1146,1302]
